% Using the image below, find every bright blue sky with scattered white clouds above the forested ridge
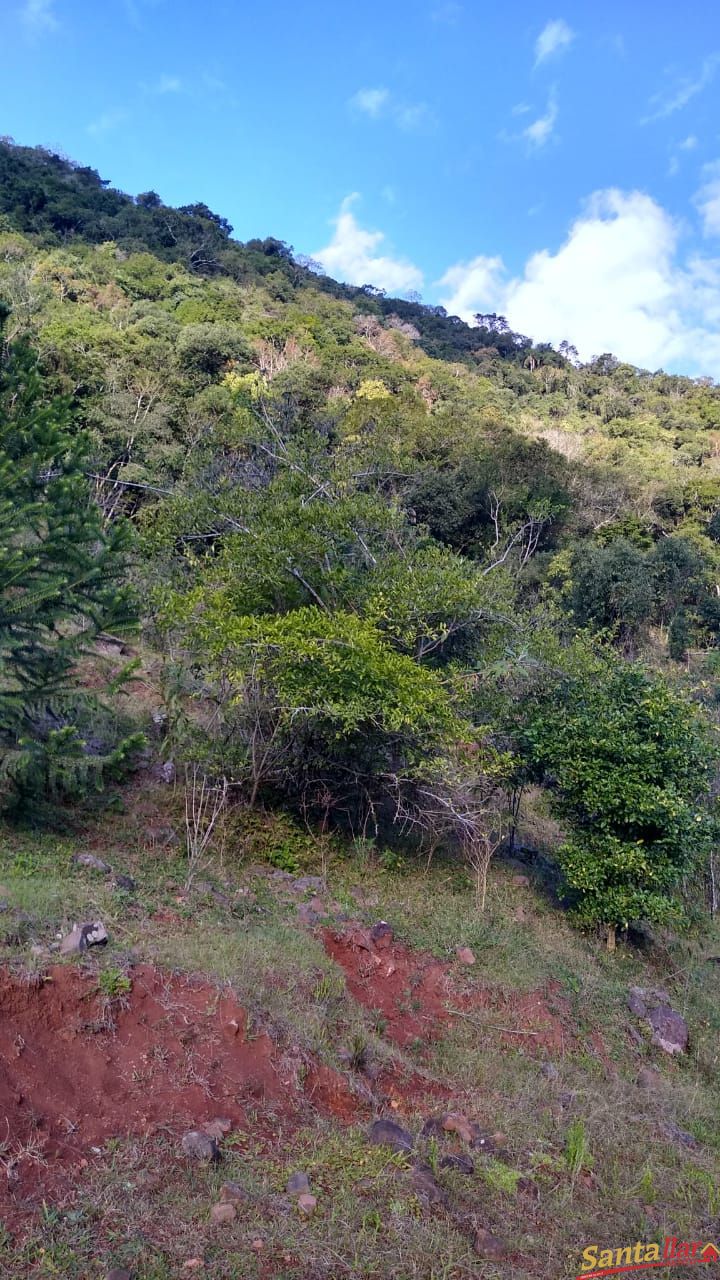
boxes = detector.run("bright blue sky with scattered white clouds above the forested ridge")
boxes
[0,0,720,378]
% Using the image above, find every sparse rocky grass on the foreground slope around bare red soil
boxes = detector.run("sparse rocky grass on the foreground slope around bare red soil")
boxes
[0,788,720,1280]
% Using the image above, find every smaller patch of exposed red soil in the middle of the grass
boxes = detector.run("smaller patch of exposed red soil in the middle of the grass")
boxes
[323,928,575,1055]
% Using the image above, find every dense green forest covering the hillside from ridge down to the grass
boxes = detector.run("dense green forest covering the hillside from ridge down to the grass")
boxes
[0,132,720,952]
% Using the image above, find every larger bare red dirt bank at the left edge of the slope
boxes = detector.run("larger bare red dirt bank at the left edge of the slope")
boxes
[0,965,355,1196]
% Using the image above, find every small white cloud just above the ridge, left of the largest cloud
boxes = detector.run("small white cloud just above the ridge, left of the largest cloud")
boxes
[313,192,423,294]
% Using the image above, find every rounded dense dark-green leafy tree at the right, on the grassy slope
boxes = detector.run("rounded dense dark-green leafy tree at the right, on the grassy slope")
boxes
[520,640,715,946]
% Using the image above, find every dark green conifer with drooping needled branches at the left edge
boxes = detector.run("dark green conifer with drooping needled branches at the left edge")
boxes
[0,332,138,808]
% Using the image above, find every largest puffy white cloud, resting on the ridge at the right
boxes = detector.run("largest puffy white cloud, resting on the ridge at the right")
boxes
[439,188,720,376]
